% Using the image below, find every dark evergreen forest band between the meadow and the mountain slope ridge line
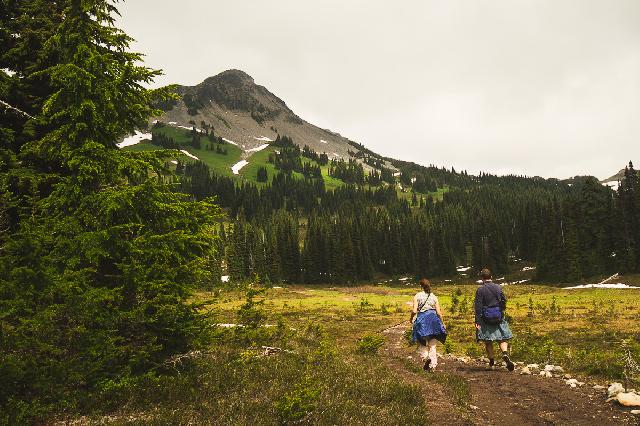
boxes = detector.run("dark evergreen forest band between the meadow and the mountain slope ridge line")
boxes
[180,147,640,284]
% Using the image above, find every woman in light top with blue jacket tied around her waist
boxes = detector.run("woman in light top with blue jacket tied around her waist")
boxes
[410,278,447,371]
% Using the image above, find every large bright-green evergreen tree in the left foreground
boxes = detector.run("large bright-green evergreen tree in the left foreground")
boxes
[0,0,218,422]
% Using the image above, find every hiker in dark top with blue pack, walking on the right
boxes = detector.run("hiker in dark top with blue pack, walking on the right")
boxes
[474,268,514,371]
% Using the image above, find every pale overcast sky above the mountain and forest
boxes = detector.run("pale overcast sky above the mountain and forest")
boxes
[117,0,640,179]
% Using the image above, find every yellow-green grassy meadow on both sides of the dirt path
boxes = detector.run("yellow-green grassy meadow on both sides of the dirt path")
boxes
[65,280,640,425]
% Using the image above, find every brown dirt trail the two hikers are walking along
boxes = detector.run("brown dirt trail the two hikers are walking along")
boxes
[382,324,640,426]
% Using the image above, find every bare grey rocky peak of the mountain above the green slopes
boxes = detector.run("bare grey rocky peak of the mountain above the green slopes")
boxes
[156,70,394,169]
